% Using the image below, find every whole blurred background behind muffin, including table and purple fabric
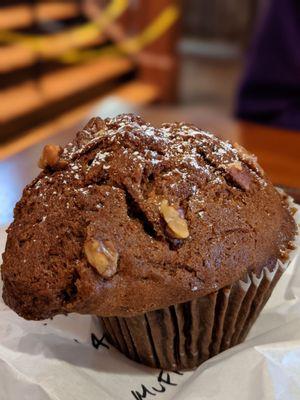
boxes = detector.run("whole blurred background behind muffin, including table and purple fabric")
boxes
[0,0,300,224]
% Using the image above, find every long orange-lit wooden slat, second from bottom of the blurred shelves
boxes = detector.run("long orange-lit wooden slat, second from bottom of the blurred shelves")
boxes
[0,57,134,122]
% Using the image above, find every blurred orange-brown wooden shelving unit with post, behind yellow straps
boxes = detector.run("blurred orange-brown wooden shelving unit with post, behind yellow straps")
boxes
[0,0,176,148]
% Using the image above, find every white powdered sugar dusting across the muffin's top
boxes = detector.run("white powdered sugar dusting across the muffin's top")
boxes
[32,115,266,217]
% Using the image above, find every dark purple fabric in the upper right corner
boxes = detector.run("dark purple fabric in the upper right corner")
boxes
[236,0,300,130]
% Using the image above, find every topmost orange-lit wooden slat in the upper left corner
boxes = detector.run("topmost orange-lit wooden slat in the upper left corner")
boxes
[0,1,80,29]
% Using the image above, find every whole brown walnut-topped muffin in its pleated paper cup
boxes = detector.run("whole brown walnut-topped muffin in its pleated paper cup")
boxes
[1,114,296,370]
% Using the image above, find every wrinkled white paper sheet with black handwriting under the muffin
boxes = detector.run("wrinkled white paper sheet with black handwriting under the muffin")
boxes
[0,206,300,400]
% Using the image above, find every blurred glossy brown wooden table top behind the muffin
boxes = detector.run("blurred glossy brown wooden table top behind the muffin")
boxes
[0,107,300,225]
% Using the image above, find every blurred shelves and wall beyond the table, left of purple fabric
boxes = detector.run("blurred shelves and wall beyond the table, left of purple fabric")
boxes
[0,0,265,155]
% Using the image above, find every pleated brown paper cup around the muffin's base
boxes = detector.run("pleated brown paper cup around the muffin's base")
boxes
[100,261,288,370]
